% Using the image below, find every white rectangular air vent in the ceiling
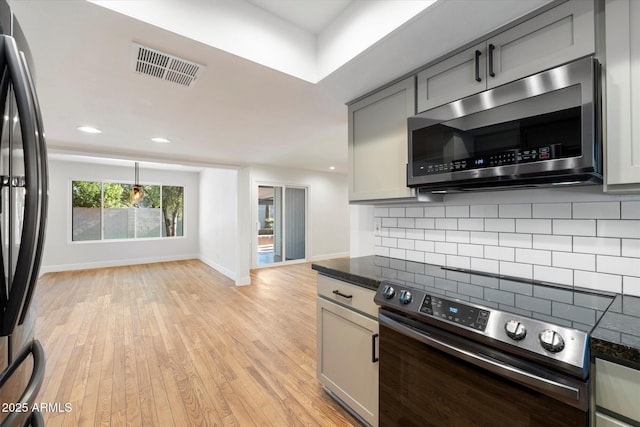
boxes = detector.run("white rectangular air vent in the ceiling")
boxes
[130,43,204,87]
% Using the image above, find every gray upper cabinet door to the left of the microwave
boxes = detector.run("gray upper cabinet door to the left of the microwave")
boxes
[349,77,415,201]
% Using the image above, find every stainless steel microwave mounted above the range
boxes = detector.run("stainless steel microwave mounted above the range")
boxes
[407,57,602,193]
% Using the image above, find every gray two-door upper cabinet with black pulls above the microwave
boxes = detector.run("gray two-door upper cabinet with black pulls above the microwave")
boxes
[418,0,595,112]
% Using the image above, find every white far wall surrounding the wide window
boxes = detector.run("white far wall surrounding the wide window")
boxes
[41,159,199,273]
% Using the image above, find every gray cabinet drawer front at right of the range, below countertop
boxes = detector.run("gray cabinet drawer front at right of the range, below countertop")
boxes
[596,359,640,421]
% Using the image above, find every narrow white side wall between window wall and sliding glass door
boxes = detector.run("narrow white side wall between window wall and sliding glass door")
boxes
[199,169,239,284]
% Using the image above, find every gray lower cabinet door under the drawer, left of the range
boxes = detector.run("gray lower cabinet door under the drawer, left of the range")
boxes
[317,298,378,426]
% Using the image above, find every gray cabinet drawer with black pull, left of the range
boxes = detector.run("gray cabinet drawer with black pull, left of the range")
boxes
[318,274,378,318]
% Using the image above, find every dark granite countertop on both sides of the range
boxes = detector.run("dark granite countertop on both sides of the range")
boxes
[312,256,640,369]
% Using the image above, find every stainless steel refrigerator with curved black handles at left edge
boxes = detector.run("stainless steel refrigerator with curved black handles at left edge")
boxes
[0,0,48,427]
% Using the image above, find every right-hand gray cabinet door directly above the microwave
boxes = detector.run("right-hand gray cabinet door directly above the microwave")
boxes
[487,0,595,88]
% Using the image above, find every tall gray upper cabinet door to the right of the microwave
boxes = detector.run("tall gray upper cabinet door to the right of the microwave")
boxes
[604,0,640,191]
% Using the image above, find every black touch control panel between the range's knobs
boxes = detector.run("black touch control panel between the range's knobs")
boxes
[420,294,490,331]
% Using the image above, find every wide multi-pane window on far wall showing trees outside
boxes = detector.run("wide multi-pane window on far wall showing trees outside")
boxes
[71,181,184,241]
